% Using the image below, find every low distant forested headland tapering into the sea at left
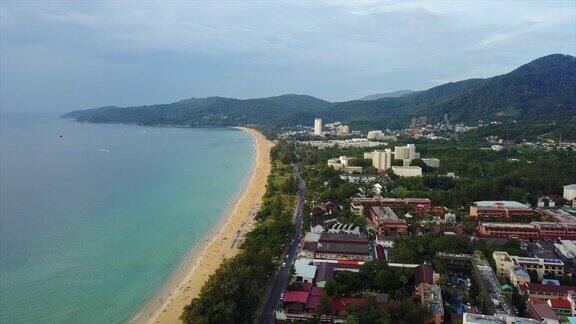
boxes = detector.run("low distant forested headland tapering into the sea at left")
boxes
[63,94,333,126]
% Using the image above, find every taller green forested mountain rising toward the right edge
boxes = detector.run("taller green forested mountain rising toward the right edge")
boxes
[324,54,576,128]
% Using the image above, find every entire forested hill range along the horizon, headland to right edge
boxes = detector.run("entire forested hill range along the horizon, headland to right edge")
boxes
[64,54,576,129]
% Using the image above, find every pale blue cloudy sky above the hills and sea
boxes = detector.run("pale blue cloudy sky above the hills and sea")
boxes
[0,0,576,112]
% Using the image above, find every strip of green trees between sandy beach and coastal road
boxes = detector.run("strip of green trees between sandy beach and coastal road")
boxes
[181,149,295,324]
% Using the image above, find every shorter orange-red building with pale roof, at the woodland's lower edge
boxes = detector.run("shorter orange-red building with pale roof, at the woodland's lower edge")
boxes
[470,201,532,220]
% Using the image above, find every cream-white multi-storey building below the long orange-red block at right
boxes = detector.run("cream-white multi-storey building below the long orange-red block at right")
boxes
[492,251,564,280]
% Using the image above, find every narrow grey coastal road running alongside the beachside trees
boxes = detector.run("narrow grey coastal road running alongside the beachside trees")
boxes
[256,164,306,324]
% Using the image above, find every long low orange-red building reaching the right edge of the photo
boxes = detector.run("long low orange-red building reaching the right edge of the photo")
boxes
[476,222,576,240]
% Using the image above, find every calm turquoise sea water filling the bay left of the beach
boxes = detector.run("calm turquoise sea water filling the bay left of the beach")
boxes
[0,115,254,323]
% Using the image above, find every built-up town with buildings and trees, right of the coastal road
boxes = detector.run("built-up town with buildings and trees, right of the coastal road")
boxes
[275,117,576,324]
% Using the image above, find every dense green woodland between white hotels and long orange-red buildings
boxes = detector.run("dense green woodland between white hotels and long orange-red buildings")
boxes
[391,145,576,207]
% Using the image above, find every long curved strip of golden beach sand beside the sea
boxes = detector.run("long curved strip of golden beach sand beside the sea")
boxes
[131,127,273,323]
